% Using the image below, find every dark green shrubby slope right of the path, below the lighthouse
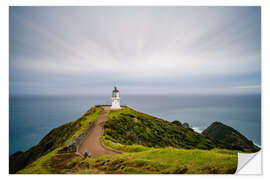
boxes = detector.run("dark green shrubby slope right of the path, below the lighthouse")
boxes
[104,108,218,149]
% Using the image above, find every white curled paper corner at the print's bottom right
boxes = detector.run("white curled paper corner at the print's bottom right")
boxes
[235,151,262,175]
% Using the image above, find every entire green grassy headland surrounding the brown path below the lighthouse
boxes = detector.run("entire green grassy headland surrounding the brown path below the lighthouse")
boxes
[11,107,258,174]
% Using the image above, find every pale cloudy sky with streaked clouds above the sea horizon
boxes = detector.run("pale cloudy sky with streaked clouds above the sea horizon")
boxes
[9,6,261,95]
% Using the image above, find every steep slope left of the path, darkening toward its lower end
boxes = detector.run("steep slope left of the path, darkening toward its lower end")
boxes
[9,107,103,173]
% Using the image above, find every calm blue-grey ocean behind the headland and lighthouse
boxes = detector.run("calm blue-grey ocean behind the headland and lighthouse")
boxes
[9,95,261,154]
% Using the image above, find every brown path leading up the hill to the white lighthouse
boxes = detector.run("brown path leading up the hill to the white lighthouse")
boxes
[79,106,119,158]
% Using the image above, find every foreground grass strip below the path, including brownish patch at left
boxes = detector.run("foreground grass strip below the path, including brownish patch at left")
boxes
[18,144,237,174]
